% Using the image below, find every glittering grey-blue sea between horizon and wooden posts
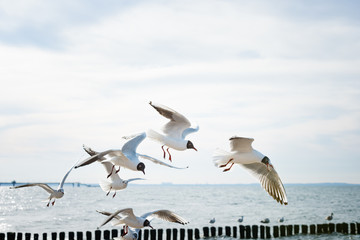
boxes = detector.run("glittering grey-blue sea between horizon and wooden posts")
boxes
[0,184,360,239]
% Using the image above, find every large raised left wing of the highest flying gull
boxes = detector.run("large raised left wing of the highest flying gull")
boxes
[150,102,191,138]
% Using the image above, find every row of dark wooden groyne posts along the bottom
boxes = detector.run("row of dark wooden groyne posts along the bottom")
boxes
[0,223,360,240]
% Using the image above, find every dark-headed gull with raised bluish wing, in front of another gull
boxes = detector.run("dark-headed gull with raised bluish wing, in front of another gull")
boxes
[75,132,188,175]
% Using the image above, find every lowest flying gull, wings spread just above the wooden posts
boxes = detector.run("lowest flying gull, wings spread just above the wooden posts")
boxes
[98,208,189,235]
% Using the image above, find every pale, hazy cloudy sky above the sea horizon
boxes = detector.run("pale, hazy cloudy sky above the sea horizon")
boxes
[0,0,360,184]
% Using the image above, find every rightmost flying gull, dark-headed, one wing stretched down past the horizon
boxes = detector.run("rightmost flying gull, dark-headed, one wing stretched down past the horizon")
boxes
[213,136,288,205]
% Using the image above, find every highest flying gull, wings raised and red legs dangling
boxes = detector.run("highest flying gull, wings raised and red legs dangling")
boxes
[148,101,199,161]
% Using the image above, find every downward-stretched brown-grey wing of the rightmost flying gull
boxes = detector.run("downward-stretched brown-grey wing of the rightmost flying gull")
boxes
[241,162,288,205]
